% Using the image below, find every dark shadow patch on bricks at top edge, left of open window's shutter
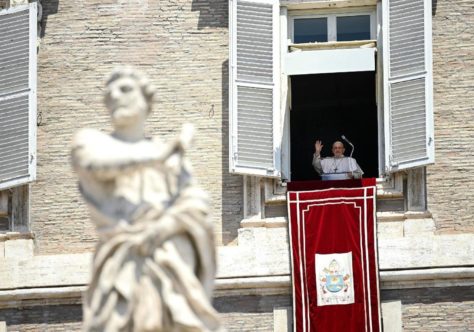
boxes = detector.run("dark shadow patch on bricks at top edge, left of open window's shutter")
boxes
[191,0,229,29]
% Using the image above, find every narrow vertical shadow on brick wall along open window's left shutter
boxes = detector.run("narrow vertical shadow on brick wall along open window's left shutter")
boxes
[221,60,243,245]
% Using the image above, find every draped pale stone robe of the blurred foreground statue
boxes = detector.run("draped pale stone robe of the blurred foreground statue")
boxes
[77,148,219,331]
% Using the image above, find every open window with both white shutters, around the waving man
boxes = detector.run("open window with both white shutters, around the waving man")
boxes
[230,0,434,180]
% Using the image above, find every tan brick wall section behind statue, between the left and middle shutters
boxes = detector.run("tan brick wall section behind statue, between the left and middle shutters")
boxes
[31,0,242,254]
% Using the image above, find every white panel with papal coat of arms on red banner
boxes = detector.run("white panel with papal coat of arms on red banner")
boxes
[315,252,354,306]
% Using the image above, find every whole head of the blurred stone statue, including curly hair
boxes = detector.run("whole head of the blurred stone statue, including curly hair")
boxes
[105,67,155,127]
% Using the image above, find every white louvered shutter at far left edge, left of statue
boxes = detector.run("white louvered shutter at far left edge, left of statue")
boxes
[0,3,37,189]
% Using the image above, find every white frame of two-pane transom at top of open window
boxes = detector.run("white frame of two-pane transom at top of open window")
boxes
[288,7,377,45]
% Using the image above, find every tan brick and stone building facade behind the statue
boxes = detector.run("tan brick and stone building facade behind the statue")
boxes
[0,0,474,331]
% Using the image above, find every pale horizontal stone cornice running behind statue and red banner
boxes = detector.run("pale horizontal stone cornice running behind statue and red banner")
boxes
[0,232,474,308]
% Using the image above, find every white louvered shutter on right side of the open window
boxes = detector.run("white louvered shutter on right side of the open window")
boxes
[382,0,434,172]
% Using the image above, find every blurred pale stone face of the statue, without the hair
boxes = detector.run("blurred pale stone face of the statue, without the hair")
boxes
[105,77,148,127]
